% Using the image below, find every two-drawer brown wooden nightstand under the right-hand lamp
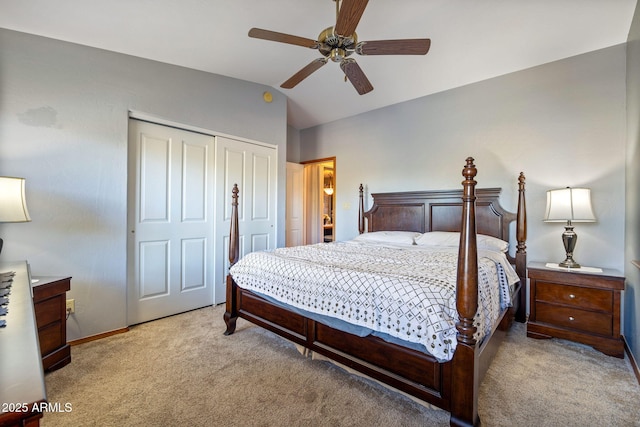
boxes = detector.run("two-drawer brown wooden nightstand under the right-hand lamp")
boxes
[527,262,625,358]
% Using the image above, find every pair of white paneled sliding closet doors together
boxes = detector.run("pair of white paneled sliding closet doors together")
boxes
[127,119,277,325]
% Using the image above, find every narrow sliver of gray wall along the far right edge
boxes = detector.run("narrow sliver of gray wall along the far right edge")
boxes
[624,7,640,368]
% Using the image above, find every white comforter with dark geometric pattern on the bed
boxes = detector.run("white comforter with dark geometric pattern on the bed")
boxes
[230,241,518,361]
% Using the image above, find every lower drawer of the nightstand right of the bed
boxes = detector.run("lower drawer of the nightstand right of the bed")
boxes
[536,302,613,336]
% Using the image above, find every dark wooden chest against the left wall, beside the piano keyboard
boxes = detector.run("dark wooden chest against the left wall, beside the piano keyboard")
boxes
[32,276,71,371]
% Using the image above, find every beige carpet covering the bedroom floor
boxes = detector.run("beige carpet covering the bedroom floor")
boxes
[42,306,640,427]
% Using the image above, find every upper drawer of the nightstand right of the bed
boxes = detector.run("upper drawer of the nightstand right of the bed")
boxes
[535,281,613,312]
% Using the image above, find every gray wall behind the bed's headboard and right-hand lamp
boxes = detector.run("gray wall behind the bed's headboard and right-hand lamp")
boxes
[300,45,637,341]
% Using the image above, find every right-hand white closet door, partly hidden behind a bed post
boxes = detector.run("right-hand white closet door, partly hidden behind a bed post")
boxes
[215,136,277,304]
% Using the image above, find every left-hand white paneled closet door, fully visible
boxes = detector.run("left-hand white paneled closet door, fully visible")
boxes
[127,120,215,325]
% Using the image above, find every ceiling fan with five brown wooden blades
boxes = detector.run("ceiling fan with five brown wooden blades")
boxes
[249,0,431,95]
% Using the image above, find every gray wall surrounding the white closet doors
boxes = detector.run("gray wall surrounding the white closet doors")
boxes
[0,29,287,340]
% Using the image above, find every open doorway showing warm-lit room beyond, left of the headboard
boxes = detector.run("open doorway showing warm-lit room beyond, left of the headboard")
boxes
[302,157,336,245]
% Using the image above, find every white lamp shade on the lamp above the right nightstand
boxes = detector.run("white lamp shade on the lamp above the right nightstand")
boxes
[544,187,596,222]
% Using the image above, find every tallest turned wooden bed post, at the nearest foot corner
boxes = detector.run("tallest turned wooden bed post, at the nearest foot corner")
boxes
[451,157,480,426]
